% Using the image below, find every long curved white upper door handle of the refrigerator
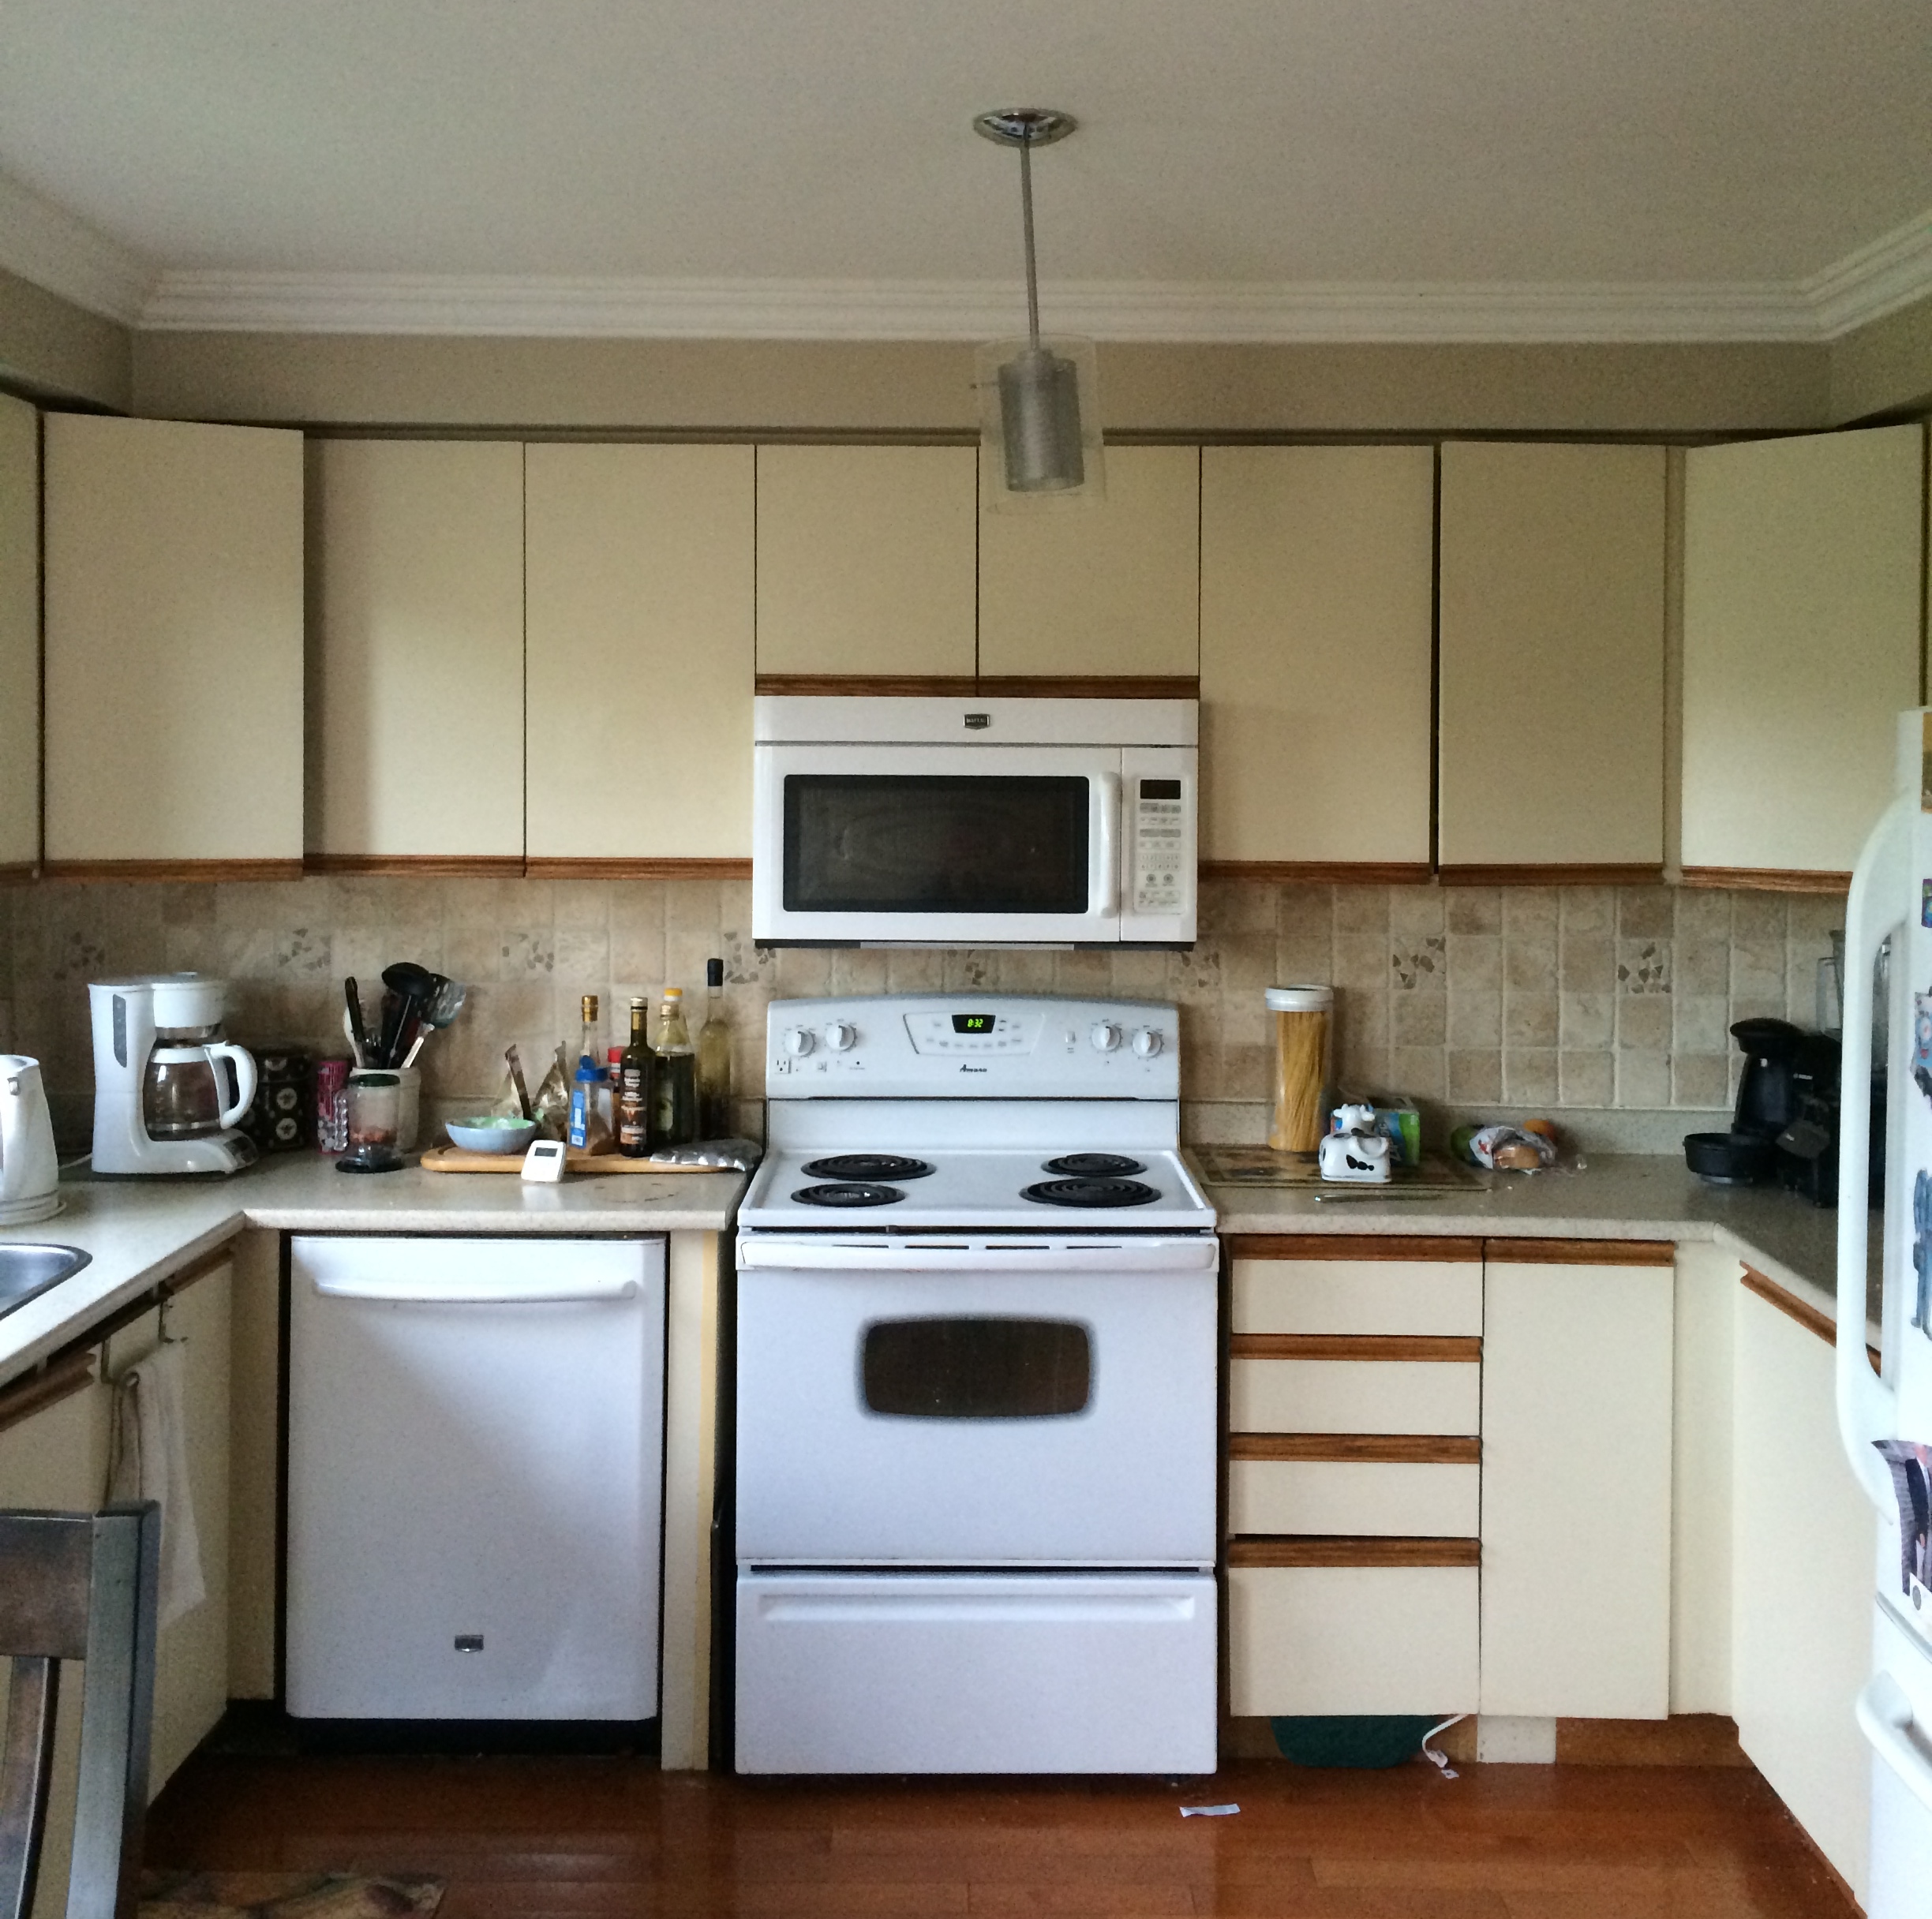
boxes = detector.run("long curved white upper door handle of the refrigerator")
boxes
[1836,792,1919,1513]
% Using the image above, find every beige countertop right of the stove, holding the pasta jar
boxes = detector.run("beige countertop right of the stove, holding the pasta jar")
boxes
[1208,1154,1880,1322]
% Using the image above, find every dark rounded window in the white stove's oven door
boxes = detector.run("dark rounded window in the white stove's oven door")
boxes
[859,1314,1094,1419]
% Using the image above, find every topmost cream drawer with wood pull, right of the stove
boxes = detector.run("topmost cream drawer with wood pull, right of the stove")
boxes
[1230,1235,1482,1337]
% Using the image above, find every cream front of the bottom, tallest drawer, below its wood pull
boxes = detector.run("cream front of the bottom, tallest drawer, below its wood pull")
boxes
[1226,1566,1478,1716]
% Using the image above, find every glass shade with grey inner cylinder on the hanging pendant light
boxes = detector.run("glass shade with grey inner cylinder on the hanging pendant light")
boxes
[975,339,1107,512]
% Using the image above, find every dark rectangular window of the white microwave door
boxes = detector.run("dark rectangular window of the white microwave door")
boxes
[784,773,1088,914]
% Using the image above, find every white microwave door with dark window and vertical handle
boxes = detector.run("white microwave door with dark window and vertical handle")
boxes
[751,744,1122,945]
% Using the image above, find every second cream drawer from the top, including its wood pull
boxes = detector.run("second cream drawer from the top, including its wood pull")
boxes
[1229,1334,1482,1436]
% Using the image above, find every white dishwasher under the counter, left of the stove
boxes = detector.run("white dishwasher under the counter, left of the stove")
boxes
[286,1236,665,1720]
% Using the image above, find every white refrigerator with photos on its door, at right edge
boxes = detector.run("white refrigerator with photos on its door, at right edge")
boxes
[1837,707,1932,1919]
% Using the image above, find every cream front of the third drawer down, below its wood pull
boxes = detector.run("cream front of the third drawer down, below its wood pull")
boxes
[1226,1459,1482,1539]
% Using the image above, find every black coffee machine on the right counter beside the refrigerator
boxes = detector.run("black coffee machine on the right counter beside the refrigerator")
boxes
[1685,1019,1855,1206]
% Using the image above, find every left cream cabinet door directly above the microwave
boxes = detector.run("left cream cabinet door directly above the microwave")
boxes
[758,447,979,680]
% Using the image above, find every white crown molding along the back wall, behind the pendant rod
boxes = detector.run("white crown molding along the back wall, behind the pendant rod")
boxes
[141,271,1818,344]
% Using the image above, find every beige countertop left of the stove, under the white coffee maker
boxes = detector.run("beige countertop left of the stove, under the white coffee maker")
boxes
[0,1152,746,1384]
